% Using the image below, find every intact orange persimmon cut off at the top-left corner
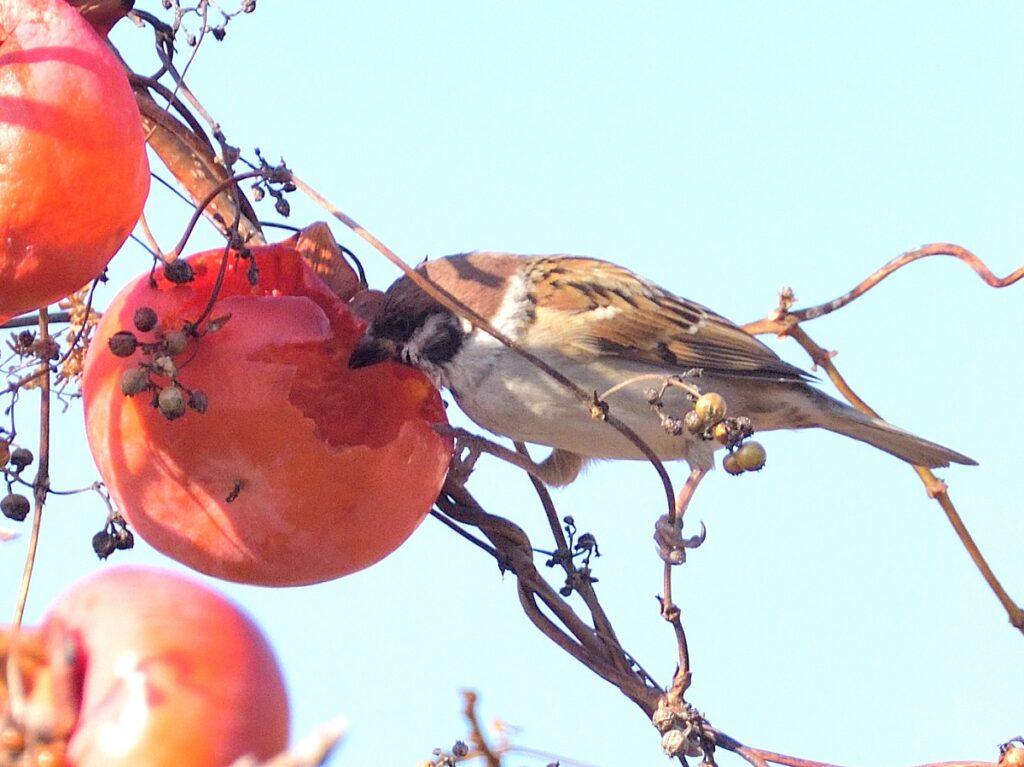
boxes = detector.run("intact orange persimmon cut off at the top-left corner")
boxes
[0,0,150,323]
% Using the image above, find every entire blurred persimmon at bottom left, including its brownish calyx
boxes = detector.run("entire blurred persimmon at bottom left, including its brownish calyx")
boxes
[0,567,289,767]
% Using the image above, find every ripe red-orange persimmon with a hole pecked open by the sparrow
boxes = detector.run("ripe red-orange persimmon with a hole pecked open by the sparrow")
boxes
[83,244,452,586]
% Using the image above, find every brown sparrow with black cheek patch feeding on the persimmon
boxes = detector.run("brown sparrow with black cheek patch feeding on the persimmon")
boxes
[349,252,976,485]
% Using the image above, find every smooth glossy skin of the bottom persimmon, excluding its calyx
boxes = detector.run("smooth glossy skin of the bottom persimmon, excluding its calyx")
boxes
[42,567,289,767]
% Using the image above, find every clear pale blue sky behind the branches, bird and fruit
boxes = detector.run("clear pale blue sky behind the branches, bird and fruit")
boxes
[0,0,1024,767]
